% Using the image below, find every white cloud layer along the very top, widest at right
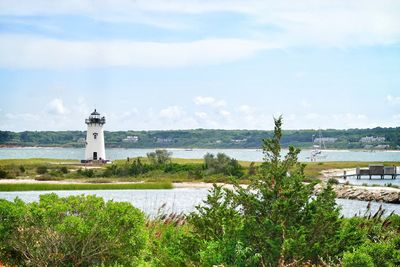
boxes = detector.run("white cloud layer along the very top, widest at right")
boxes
[0,0,400,47]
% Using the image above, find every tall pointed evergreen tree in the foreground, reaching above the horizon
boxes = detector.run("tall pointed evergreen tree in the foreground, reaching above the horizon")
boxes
[189,117,339,266]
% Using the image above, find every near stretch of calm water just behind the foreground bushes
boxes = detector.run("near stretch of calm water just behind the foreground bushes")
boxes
[0,188,400,217]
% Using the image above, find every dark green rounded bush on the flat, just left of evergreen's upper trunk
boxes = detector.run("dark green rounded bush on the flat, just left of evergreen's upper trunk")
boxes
[204,153,244,177]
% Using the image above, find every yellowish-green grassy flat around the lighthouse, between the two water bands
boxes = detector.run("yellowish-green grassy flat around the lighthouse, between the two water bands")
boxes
[0,157,400,186]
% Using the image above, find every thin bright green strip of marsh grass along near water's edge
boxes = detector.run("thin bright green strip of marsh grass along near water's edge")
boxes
[0,182,172,192]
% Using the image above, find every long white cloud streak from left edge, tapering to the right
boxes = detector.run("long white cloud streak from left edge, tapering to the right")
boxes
[0,34,274,69]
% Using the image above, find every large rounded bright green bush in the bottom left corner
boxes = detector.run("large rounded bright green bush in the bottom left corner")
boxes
[0,194,147,266]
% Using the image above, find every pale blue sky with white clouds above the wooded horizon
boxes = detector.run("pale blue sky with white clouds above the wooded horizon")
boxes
[0,0,400,131]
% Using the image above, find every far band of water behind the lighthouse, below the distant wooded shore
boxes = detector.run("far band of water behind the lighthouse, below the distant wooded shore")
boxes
[0,148,400,161]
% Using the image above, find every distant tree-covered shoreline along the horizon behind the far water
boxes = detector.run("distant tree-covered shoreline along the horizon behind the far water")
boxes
[0,127,400,149]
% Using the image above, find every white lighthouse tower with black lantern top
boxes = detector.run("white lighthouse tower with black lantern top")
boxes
[85,109,106,161]
